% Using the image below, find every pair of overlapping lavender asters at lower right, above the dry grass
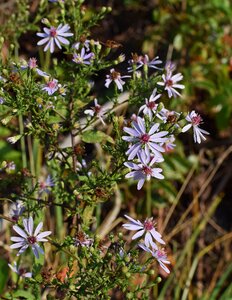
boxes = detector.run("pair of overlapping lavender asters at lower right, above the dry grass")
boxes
[122,215,170,273]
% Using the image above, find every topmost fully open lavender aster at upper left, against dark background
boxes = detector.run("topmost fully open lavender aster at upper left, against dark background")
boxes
[36,24,73,53]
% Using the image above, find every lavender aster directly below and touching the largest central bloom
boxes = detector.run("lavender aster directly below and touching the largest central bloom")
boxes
[124,151,164,190]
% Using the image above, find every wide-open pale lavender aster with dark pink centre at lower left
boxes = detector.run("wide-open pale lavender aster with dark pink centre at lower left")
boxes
[10,217,51,258]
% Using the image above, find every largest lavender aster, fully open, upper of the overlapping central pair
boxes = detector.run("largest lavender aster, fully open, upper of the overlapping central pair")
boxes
[122,117,168,160]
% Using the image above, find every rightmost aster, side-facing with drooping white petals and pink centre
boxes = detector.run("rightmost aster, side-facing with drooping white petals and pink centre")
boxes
[182,110,209,144]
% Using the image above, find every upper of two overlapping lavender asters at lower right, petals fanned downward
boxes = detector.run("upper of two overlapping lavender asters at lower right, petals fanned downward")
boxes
[122,215,165,249]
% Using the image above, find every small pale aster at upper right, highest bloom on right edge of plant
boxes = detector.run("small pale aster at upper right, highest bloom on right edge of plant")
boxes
[157,72,184,98]
